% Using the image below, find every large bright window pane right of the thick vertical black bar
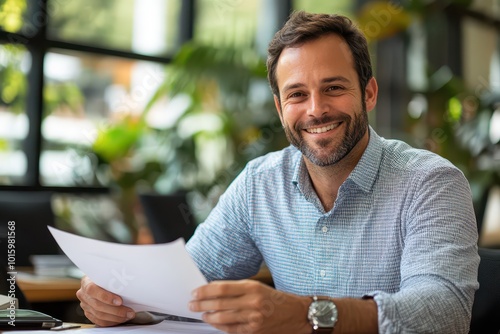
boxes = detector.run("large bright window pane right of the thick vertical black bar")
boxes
[40,50,165,186]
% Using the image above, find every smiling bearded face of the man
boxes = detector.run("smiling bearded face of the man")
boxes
[275,34,376,166]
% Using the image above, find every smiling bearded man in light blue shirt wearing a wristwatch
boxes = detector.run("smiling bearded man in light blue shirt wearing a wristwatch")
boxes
[77,12,479,334]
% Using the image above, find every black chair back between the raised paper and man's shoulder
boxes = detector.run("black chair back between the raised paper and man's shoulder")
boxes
[139,193,196,243]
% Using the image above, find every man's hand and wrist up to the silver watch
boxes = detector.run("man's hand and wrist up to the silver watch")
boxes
[189,280,311,333]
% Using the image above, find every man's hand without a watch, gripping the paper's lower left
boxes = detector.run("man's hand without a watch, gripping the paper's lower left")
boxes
[76,276,135,327]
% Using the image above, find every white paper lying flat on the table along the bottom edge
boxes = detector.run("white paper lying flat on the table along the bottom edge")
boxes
[3,320,223,334]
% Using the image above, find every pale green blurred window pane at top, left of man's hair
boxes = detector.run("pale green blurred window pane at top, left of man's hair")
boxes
[194,0,261,46]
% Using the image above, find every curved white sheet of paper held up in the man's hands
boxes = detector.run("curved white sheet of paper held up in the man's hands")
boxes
[49,226,207,319]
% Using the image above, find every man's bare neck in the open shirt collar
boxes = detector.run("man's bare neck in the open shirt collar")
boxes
[304,131,370,212]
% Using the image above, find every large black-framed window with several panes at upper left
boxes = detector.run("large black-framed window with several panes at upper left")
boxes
[0,0,193,191]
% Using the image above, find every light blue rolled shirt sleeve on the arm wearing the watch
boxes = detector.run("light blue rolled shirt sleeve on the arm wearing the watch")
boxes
[368,167,479,333]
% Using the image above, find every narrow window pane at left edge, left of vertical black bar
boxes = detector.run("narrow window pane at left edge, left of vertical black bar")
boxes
[0,44,31,185]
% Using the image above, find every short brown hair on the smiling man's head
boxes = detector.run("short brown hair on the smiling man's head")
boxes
[267,11,373,98]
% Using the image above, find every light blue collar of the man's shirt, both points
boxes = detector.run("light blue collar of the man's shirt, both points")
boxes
[292,126,383,194]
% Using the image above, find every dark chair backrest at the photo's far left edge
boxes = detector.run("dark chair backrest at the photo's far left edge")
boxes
[0,191,60,267]
